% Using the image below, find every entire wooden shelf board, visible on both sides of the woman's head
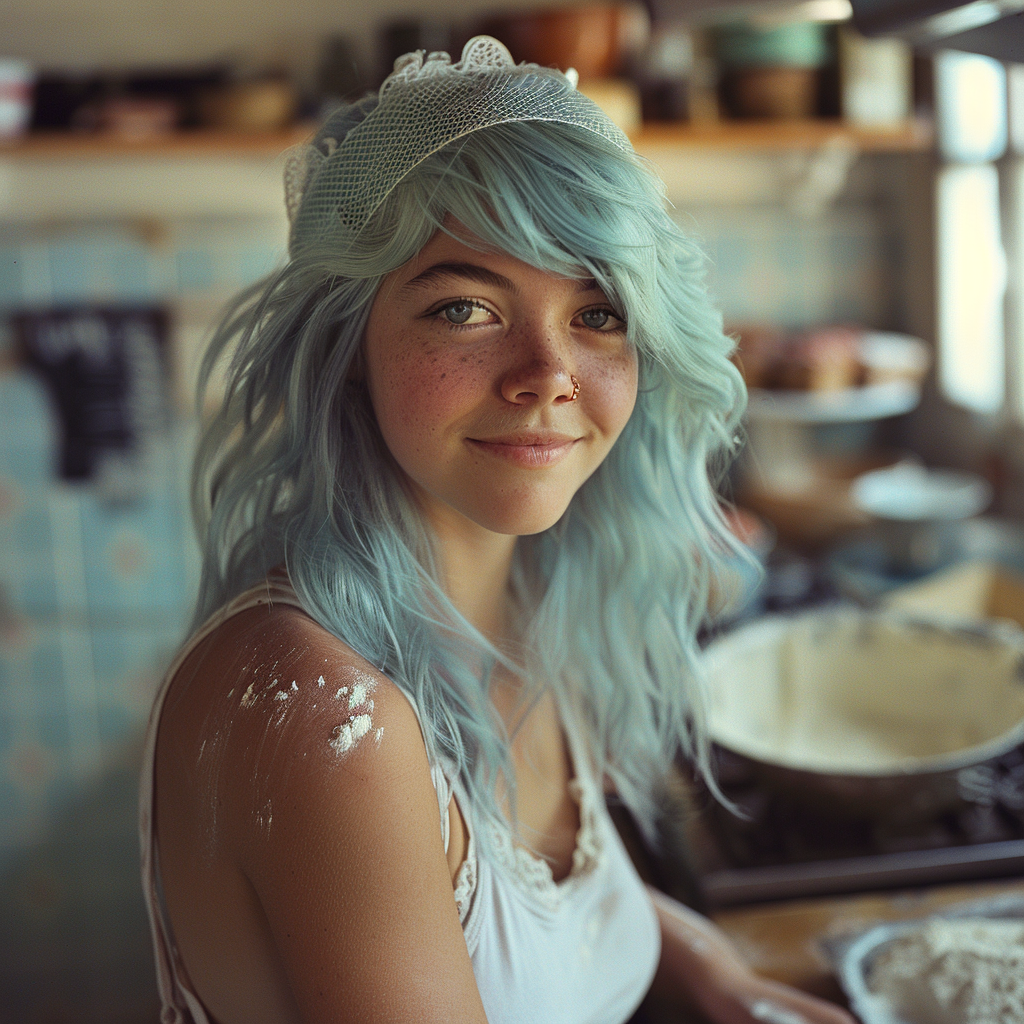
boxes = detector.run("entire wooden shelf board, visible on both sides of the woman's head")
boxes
[0,119,932,159]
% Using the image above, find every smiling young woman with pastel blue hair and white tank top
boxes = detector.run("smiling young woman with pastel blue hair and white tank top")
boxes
[140,38,849,1024]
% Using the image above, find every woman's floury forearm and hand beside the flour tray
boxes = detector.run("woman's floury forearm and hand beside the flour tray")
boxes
[649,889,855,1024]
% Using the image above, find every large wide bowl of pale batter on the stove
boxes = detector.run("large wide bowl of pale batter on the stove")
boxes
[706,606,1024,820]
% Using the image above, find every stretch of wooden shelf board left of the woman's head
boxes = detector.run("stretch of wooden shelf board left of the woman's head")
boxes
[0,124,316,160]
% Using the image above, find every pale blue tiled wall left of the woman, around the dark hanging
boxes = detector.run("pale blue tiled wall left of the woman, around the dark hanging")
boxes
[0,216,284,1024]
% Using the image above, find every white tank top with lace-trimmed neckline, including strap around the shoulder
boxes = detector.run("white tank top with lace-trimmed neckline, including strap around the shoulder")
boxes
[139,577,660,1024]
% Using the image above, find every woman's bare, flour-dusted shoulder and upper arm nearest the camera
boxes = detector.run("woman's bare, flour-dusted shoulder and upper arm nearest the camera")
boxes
[157,606,482,1024]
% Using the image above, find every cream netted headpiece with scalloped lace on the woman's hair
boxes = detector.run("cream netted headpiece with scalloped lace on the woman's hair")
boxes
[285,36,632,252]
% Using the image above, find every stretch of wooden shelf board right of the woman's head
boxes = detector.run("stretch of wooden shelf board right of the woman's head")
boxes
[632,118,932,153]
